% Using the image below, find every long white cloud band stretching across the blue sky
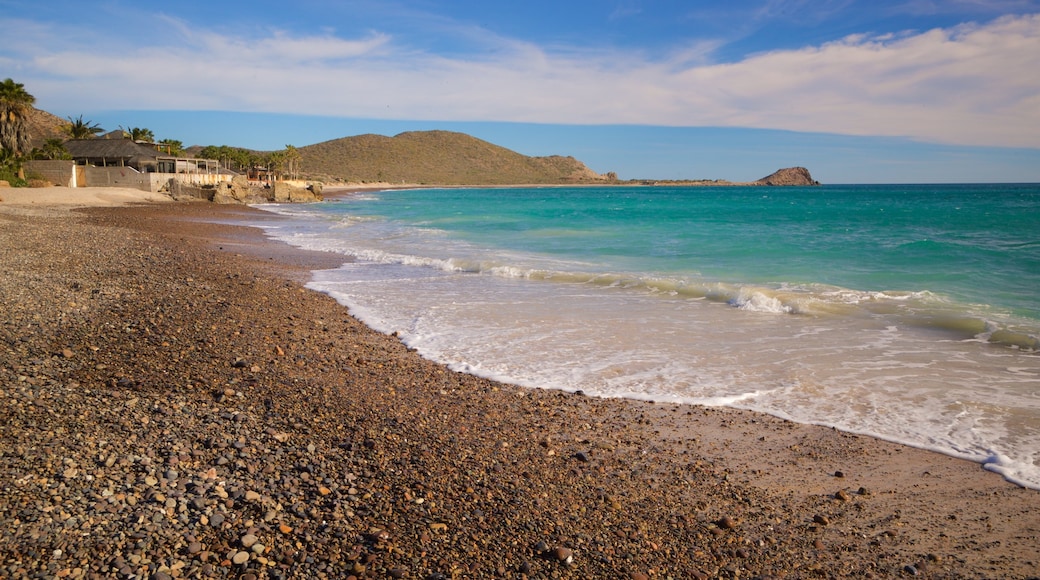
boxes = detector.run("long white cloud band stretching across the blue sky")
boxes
[8,16,1040,148]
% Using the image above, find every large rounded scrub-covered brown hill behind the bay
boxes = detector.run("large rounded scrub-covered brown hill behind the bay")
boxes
[300,131,606,185]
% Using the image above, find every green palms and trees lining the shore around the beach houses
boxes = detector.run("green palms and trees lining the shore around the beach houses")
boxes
[0,78,301,185]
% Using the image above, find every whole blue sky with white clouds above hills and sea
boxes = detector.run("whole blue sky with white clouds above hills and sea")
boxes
[0,0,1040,183]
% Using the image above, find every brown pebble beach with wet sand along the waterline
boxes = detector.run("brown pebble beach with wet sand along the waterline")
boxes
[0,188,1040,578]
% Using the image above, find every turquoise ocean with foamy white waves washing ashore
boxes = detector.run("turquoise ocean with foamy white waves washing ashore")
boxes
[258,184,1040,489]
